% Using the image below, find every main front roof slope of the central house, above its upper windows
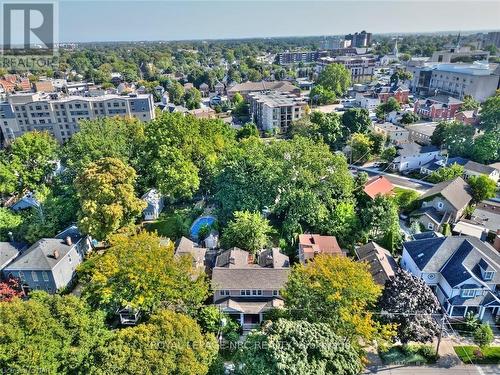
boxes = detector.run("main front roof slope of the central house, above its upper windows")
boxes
[212,267,290,290]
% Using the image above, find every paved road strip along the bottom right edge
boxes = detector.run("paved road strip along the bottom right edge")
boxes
[363,365,500,375]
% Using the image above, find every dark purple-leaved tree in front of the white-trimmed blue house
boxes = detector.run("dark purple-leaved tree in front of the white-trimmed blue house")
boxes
[379,269,440,344]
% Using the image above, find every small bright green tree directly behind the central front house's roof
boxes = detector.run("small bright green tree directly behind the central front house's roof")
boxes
[221,211,273,254]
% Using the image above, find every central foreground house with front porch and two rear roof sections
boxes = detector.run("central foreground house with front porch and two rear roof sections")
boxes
[212,248,290,330]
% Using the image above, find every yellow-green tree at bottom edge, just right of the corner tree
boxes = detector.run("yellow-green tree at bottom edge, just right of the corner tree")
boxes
[92,310,218,375]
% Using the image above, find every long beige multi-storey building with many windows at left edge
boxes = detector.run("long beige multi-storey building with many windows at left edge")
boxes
[0,92,155,142]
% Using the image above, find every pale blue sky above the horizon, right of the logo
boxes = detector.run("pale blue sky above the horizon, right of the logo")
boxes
[59,0,500,42]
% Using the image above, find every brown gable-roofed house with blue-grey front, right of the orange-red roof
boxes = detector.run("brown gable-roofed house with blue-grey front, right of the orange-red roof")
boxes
[410,177,472,231]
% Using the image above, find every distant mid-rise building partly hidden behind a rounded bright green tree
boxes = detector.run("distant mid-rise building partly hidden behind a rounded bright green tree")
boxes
[316,55,376,83]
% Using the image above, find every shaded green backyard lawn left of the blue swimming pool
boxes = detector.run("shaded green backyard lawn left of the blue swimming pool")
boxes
[144,208,200,240]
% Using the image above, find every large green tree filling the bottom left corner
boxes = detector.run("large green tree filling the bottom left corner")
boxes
[0,291,109,374]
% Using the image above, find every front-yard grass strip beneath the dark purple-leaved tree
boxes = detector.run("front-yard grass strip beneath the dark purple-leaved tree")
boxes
[379,345,437,365]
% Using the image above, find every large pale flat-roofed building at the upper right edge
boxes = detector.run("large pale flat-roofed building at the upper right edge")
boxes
[408,62,500,102]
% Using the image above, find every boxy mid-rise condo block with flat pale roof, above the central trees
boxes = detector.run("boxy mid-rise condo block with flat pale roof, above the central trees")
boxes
[248,91,307,133]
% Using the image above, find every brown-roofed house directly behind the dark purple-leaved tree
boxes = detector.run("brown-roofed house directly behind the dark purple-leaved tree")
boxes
[355,241,398,285]
